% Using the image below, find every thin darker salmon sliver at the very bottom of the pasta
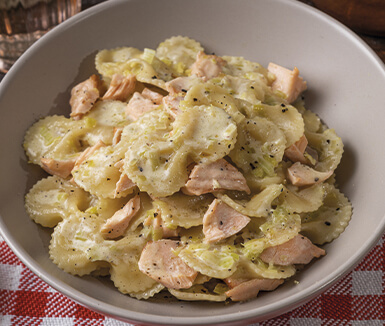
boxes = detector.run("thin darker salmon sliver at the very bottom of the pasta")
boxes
[226,278,284,301]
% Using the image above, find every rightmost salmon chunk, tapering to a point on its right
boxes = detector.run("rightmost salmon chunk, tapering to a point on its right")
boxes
[287,162,333,187]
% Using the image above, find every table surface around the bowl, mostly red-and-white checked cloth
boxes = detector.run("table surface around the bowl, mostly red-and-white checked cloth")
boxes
[0,0,385,326]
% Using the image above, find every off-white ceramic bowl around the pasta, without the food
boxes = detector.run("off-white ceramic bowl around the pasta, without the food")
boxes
[0,0,385,325]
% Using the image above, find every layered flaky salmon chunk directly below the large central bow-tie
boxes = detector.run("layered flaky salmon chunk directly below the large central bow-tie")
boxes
[182,158,250,196]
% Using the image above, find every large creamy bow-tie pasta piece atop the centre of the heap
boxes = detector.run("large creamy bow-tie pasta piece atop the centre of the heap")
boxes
[124,106,236,197]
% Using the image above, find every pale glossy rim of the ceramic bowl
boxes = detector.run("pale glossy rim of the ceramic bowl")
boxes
[0,0,385,325]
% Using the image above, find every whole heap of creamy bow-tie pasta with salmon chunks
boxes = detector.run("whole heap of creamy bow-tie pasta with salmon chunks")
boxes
[24,36,352,302]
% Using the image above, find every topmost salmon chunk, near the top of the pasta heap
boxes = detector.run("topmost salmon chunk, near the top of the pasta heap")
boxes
[191,51,226,81]
